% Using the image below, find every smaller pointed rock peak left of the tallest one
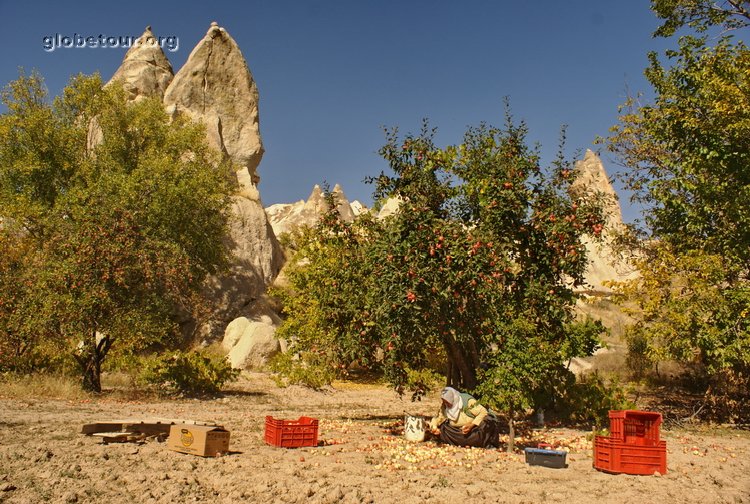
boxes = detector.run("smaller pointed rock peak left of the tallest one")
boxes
[107,26,174,101]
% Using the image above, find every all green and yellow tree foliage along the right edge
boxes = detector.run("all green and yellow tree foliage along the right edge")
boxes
[609,5,750,412]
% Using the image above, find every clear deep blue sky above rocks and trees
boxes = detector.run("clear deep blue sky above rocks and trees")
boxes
[0,0,674,221]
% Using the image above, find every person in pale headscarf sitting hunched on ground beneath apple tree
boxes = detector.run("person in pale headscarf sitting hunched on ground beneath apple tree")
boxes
[430,387,500,448]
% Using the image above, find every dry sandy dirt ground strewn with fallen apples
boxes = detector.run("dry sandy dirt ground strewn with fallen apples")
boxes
[0,374,750,504]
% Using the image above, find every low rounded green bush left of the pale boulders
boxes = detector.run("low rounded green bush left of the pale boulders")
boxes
[138,351,240,394]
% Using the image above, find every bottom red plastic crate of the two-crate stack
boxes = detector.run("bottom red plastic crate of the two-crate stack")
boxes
[594,436,667,476]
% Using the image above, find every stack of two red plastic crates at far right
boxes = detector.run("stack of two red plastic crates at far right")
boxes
[594,410,667,475]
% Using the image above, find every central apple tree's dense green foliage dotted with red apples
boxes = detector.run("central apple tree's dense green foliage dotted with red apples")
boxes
[277,112,602,420]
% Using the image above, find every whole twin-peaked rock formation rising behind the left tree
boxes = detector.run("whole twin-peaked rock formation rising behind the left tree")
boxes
[108,23,284,339]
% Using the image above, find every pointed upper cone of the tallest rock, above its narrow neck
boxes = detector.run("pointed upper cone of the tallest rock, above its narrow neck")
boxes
[164,22,263,186]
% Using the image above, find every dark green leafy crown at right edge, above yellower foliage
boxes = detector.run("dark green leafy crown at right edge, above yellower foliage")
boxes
[609,38,750,264]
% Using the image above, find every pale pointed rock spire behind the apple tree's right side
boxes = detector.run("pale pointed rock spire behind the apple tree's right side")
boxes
[571,150,637,293]
